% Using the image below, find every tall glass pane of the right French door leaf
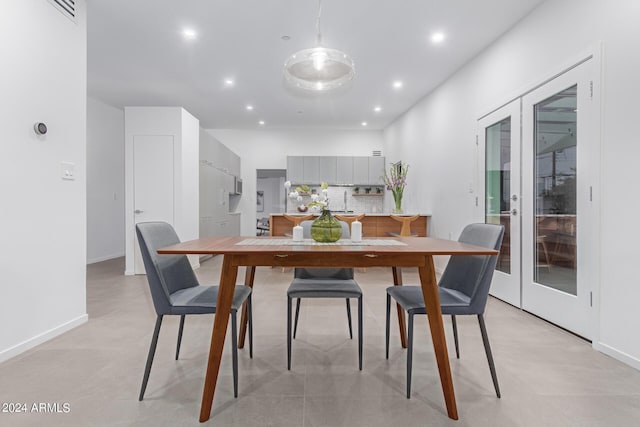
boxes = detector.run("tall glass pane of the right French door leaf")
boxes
[533,86,578,295]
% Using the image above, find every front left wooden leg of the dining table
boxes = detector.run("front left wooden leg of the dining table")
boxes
[200,255,238,423]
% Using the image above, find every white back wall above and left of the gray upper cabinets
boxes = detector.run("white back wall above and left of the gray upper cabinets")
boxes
[207,129,384,236]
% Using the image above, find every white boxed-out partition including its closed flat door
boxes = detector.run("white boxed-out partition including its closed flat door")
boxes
[125,107,199,274]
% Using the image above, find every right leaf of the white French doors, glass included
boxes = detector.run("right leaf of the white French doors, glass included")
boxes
[522,59,599,338]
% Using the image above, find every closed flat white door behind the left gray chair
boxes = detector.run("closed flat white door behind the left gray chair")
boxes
[132,135,174,274]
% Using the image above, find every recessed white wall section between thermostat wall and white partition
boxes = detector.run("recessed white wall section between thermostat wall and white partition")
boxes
[87,97,124,264]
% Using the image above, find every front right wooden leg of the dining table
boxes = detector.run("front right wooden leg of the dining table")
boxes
[418,255,458,420]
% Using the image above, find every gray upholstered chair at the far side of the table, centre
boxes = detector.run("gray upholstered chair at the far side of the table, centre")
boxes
[287,221,362,370]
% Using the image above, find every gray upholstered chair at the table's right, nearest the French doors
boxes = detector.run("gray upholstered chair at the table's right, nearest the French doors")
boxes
[386,224,504,398]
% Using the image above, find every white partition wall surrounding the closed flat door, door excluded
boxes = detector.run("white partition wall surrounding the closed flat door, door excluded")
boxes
[125,107,200,274]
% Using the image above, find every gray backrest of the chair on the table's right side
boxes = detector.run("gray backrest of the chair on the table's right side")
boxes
[438,224,504,314]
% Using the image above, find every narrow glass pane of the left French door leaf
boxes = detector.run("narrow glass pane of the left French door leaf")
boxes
[484,117,511,274]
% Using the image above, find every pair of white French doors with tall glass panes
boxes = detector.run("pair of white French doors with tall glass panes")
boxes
[478,60,599,338]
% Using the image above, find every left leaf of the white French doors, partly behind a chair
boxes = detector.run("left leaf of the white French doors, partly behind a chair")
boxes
[478,99,521,307]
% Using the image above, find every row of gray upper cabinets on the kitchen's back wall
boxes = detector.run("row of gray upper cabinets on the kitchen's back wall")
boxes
[287,156,385,185]
